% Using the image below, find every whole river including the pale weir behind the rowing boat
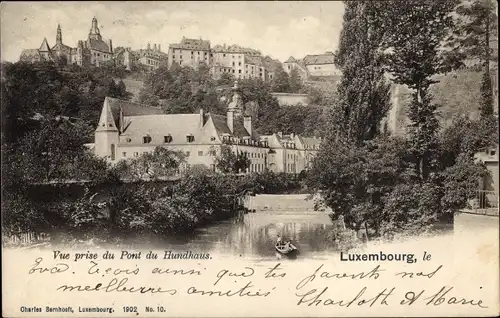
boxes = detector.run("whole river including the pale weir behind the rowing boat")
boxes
[123,195,335,260]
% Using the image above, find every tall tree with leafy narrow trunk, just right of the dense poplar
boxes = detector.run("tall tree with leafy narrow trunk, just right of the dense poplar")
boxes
[384,0,460,179]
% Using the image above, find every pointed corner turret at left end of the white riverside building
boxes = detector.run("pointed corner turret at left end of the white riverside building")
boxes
[94,97,120,162]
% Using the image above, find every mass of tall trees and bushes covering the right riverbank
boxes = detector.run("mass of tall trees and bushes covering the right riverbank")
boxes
[308,1,498,240]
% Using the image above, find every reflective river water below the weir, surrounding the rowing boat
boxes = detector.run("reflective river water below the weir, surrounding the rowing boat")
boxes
[144,211,334,259]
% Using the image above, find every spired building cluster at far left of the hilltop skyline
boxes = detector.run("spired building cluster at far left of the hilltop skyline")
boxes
[19,17,113,66]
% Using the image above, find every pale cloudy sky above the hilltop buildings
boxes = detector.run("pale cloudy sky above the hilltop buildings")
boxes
[0,1,344,62]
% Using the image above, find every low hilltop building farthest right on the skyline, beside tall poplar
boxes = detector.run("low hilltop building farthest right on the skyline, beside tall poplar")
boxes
[283,52,340,79]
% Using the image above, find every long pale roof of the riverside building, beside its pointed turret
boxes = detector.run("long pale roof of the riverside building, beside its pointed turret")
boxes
[120,114,202,146]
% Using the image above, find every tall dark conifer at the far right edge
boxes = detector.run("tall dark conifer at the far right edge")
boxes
[456,0,498,117]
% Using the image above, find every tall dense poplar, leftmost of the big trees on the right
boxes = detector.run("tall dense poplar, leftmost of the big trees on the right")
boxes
[330,1,390,145]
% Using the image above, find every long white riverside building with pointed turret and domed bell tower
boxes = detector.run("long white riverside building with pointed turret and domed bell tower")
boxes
[91,80,321,173]
